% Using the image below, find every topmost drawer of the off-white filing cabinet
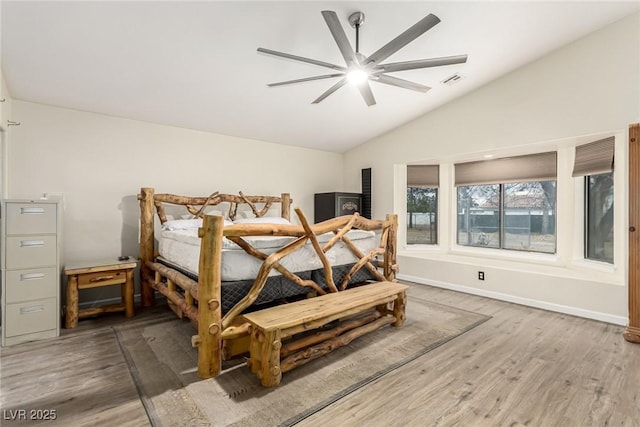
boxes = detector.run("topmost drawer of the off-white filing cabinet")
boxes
[7,203,57,234]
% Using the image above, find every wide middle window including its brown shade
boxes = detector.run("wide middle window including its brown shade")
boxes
[455,152,556,253]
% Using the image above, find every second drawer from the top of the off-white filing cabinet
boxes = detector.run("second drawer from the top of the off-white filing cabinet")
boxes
[5,236,58,269]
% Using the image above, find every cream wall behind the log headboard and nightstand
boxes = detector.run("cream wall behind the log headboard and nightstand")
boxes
[8,100,342,270]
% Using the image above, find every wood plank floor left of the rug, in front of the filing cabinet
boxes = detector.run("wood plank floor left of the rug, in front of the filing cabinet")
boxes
[0,306,168,427]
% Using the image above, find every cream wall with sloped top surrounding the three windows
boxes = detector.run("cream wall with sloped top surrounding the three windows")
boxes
[344,14,640,323]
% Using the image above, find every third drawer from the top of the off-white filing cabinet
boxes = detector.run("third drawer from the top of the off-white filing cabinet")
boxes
[5,267,59,303]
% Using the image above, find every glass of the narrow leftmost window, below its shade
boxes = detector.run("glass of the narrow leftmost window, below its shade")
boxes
[407,187,438,245]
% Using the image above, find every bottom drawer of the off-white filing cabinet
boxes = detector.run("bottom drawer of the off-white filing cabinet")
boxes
[2,298,58,337]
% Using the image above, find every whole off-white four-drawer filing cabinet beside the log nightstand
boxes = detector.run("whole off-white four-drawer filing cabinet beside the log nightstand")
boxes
[1,199,62,347]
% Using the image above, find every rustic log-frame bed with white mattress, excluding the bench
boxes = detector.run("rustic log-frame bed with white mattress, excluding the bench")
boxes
[138,187,397,378]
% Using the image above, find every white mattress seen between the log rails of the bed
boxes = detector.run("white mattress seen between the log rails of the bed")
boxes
[158,228,380,281]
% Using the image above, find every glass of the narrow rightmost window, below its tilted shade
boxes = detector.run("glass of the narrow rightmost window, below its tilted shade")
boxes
[584,172,613,264]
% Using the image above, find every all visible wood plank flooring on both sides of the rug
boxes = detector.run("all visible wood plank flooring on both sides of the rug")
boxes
[0,285,640,427]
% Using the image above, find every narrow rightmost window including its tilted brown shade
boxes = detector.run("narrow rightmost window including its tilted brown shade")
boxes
[573,136,615,264]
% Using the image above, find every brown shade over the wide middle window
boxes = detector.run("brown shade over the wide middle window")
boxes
[455,151,557,186]
